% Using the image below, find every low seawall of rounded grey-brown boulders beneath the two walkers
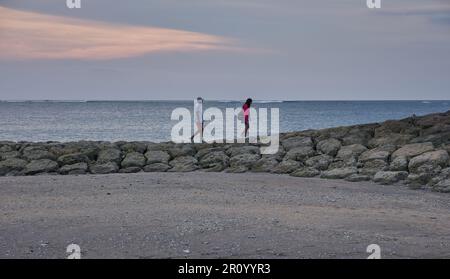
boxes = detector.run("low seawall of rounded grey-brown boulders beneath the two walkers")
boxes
[0,111,450,192]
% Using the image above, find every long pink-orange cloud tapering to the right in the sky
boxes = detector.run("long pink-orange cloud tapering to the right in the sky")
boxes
[0,7,234,60]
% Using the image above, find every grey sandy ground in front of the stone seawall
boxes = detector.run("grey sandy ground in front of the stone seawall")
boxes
[0,172,450,258]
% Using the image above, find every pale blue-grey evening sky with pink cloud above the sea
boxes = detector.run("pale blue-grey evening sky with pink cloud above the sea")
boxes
[0,0,450,100]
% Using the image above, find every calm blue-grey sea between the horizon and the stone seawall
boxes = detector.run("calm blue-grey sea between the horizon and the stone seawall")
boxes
[0,101,450,142]
